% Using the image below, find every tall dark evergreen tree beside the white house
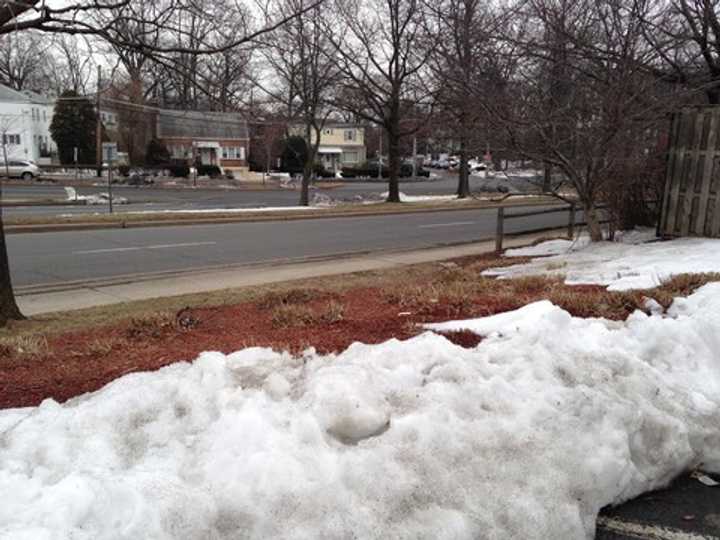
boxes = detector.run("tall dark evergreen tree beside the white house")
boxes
[50,90,97,165]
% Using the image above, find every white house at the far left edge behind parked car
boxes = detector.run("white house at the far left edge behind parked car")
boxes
[0,84,57,164]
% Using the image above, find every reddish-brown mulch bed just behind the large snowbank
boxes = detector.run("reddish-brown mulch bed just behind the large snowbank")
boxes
[0,288,492,408]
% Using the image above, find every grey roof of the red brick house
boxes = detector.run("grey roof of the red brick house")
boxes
[157,109,248,139]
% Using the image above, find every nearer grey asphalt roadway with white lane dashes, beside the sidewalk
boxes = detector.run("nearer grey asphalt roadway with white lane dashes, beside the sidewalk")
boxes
[7,205,567,286]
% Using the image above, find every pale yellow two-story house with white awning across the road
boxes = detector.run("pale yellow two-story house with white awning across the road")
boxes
[292,122,367,171]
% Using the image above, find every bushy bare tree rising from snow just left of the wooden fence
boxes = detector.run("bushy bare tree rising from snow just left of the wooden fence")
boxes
[493,0,667,240]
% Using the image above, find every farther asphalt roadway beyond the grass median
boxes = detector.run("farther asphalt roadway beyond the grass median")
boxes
[3,171,536,216]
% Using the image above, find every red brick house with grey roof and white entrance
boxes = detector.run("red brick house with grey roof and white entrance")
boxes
[156,109,249,174]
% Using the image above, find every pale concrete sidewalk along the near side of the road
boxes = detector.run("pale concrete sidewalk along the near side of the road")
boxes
[16,231,562,315]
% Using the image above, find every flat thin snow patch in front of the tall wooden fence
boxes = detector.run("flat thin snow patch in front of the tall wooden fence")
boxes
[483,229,720,291]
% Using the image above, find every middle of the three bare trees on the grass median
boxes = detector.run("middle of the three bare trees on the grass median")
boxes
[333,0,433,202]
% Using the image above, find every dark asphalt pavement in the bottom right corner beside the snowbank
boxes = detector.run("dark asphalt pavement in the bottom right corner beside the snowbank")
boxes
[595,474,720,540]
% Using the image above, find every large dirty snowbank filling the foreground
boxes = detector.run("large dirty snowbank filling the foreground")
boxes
[0,284,720,540]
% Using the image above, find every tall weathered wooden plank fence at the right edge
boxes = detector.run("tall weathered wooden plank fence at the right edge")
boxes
[659,107,720,237]
